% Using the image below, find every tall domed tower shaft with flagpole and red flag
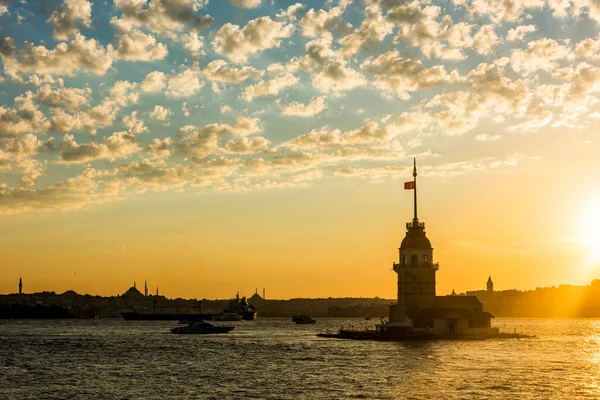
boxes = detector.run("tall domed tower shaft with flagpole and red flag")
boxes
[390,160,438,322]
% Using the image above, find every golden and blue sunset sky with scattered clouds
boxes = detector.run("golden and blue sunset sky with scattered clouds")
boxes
[0,0,600,299]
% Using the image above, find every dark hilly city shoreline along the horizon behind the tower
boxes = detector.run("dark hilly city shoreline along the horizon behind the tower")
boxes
[5,277,600,318]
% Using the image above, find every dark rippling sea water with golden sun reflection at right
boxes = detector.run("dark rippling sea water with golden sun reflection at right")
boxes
[0,318,600,399]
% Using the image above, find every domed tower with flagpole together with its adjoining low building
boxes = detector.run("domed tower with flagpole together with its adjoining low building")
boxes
[390,161,497,335]
